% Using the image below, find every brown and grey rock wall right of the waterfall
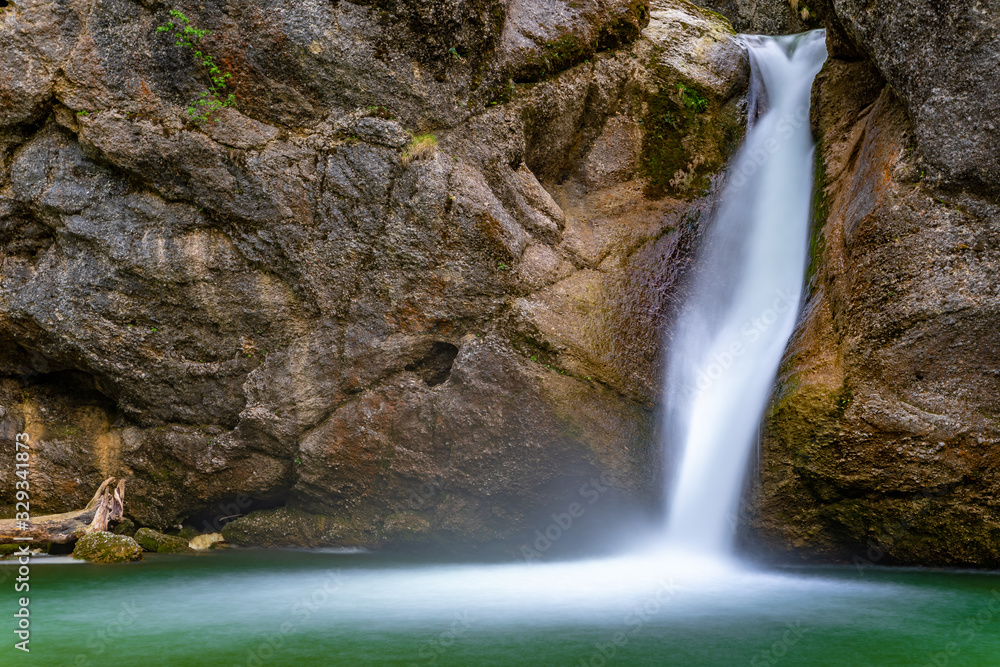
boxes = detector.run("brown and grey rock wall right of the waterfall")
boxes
[750,5,1000,567]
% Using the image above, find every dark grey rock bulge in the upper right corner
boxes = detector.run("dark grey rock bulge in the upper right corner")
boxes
[834,0,1000,197]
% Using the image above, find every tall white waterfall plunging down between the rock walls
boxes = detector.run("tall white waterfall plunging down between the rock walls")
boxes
[664,30,826,555]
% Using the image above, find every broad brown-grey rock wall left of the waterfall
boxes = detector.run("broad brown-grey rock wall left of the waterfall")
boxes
[0,0,746,545]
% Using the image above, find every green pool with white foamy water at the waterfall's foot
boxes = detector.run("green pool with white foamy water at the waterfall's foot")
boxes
[0,551,1000,667]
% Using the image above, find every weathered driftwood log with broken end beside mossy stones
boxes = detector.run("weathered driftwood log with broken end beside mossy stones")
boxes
[0,477,125,544]
